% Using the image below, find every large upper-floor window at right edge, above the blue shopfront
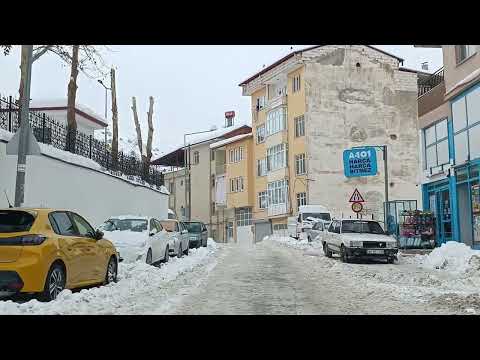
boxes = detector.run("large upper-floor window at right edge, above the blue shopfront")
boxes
[452,87,480,165]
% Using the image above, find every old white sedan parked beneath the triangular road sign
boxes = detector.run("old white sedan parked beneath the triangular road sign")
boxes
[322,219,398,263]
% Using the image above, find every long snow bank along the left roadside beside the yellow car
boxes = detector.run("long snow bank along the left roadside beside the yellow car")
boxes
[0,239,217,315]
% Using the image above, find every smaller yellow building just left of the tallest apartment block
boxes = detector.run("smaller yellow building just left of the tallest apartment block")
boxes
[210,131,255,243]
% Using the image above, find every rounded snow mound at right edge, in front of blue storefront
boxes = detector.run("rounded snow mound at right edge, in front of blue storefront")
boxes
[422,241,480,274]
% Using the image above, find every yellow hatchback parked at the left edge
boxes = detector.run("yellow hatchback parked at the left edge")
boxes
[0,208,119,301]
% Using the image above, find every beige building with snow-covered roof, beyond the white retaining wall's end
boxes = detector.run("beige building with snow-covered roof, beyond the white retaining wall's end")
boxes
[152,116,251,232]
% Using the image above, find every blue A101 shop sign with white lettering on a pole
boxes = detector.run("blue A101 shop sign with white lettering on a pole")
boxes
[343,147,377,177]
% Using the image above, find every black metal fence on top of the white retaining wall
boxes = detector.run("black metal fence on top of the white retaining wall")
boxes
[0,95,164,188]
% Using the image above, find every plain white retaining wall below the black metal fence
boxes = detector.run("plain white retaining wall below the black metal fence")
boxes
[0,142,168,226]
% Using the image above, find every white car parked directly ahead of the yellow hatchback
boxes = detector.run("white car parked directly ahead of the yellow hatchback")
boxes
[99,215,170,264]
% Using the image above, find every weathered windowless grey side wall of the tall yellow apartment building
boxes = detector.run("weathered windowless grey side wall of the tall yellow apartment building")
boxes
[304,45,420,219]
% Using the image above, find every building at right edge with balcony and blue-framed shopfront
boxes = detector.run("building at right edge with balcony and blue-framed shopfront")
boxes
[418,45,480,248]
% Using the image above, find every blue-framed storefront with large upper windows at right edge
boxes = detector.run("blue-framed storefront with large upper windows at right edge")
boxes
[422,83,480,249]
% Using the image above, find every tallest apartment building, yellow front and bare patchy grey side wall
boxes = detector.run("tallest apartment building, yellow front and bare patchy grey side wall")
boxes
[240,45,420,231]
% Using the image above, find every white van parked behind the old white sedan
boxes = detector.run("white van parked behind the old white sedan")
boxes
[288,205,332,239]
